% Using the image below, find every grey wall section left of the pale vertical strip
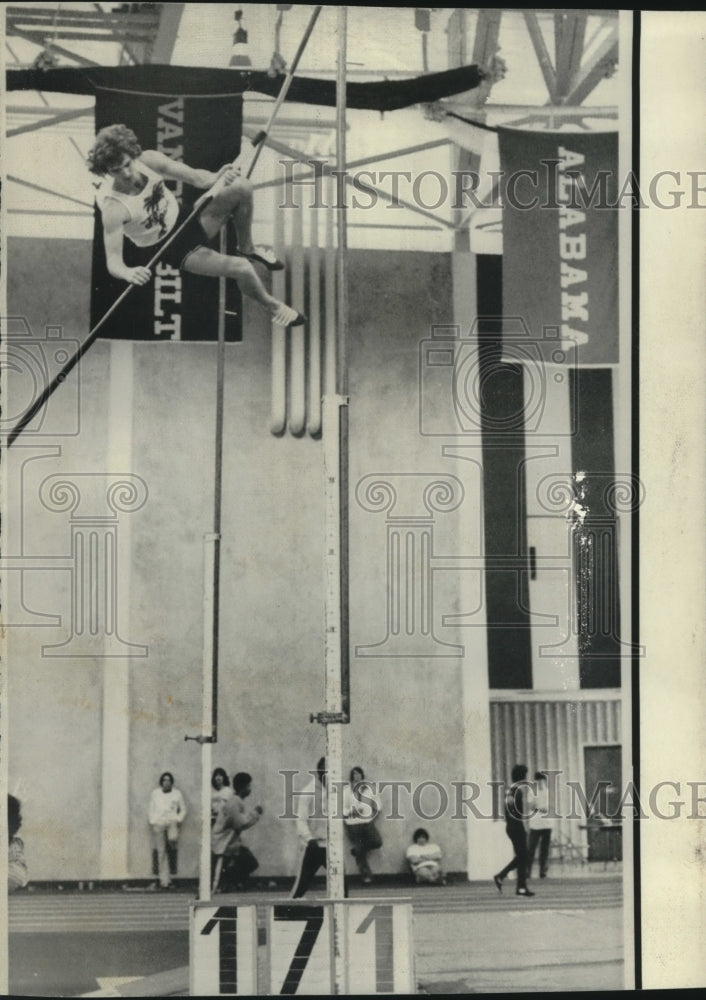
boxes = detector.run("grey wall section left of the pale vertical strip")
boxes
[2,239,103,879]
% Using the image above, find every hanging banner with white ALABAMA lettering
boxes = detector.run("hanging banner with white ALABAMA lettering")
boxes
[498,129,619,366]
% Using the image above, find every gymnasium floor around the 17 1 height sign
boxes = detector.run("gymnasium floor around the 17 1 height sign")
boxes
[9,869,624,997]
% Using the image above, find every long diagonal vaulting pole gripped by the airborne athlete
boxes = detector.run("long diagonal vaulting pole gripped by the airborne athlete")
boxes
[7,6,321,448]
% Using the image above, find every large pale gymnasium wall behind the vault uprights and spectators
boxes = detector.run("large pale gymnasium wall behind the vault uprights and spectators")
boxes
[8,240,476,880]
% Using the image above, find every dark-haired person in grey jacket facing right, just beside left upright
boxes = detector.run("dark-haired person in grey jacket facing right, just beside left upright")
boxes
[211,771,263,892]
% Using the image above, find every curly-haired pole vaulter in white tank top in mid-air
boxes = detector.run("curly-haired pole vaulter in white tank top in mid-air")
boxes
[88,125,306,326]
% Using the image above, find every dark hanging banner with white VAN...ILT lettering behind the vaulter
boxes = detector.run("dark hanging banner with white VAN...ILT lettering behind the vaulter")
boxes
[91,89,242,340]
